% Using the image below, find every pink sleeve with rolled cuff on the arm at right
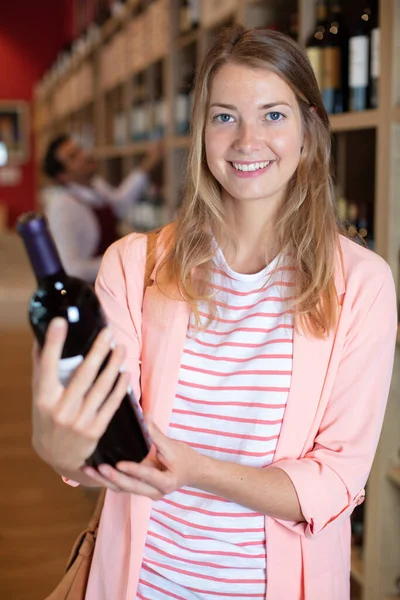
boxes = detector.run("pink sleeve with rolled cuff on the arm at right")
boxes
[273,263,397,537]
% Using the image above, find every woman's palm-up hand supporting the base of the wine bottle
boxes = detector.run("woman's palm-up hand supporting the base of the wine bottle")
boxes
[84,420,202,500]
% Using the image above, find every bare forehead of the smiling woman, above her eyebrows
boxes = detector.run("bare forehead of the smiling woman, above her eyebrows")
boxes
[210,63,296,104]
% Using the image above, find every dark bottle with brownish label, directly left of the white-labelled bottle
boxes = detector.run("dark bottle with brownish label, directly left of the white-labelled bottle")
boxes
[322,0,348,114]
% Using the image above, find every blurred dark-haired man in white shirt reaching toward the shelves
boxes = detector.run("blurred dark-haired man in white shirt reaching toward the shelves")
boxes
[42,135,162,283]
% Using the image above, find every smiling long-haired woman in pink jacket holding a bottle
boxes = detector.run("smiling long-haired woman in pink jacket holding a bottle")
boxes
[34,27,396,600]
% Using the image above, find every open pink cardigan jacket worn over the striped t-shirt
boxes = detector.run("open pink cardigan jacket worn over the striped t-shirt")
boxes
[81,227,397,600]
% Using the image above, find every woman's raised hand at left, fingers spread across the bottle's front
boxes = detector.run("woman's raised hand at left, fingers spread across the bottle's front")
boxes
[33,318,129,472]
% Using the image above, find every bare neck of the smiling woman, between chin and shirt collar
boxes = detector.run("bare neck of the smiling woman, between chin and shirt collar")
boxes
[222,196,279,273]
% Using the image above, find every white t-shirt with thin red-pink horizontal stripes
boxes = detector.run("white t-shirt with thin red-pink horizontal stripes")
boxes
[137,250,293,600]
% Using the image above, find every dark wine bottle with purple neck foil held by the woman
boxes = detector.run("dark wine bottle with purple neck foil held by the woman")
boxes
[17,213,151,468]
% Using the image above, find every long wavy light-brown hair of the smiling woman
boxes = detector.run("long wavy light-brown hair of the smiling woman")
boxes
[157,26,340,337]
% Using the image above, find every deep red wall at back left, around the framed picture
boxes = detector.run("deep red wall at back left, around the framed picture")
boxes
[0,0,73,226]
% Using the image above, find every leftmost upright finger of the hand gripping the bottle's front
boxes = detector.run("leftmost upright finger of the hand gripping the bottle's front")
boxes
[38,317,68,397]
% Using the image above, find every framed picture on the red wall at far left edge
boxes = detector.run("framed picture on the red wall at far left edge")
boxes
[0,100,29,164]
